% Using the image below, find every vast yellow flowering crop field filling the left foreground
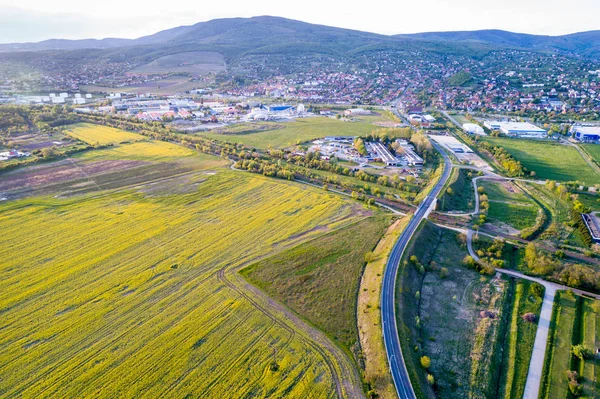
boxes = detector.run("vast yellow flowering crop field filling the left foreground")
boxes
[0,142,363,398]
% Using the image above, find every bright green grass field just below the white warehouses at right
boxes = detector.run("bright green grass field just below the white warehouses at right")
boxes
[483,137,600,185]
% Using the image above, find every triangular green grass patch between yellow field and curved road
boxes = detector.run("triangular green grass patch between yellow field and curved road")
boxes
[241,215,390,353]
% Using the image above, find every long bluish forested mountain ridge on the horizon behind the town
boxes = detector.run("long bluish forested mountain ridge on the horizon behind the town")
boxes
[0,16,600,59]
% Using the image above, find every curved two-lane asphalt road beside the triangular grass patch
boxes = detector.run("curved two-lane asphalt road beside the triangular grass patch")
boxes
[381,142,452,399]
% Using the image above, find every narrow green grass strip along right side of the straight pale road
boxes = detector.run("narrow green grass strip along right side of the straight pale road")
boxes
[540,291,577,399]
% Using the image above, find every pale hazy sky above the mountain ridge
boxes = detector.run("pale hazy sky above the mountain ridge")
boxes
[0,0,600,43]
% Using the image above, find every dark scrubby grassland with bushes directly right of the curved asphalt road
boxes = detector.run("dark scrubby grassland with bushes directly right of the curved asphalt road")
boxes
[396,223,510,398]
